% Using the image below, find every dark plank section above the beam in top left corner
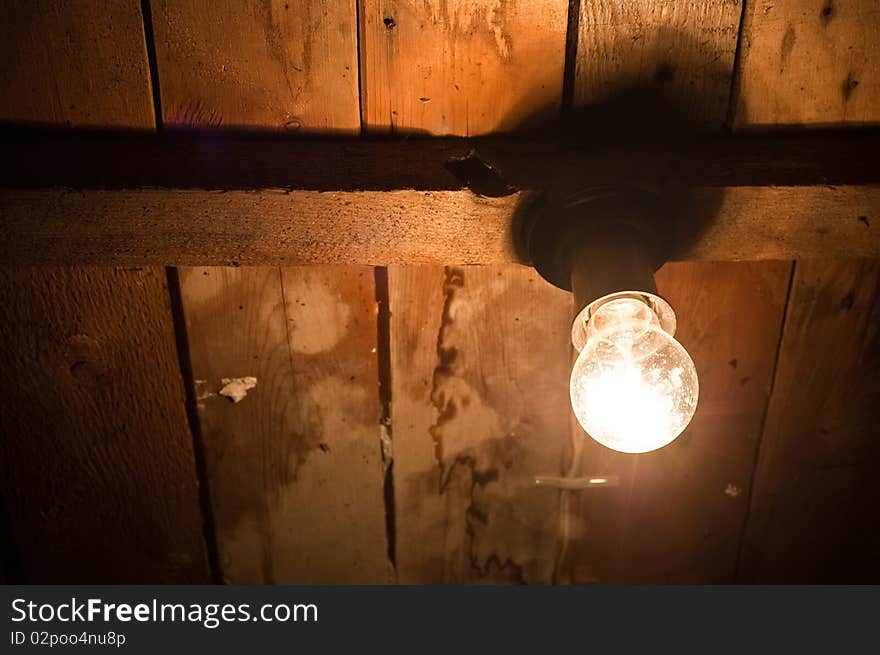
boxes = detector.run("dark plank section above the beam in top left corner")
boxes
[0,0,154,130]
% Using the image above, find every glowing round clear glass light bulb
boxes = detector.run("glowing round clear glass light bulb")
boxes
[571,297,699,453]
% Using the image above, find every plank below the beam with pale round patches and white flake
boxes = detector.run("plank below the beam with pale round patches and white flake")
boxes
[181,267,388,584]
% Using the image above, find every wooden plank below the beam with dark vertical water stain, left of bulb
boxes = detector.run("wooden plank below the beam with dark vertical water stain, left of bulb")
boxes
[389,266,572,583]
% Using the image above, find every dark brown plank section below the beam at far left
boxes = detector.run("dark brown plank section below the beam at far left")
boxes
[0,268,208,584]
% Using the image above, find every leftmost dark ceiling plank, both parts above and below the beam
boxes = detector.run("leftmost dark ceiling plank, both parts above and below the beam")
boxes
[0,0,209,583]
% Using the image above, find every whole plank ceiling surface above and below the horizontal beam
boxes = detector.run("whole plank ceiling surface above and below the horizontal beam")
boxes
[0,0,880,584]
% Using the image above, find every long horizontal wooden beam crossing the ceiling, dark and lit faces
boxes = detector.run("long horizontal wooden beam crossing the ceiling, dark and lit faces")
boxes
[0,130,880,265]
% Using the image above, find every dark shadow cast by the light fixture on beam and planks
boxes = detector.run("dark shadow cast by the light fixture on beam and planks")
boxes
[496,28,743,262]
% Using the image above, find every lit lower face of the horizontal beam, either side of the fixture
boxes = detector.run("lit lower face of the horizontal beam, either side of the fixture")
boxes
[0,186,880,266]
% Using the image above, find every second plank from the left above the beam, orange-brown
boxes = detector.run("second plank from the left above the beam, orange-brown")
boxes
[152,0,360,132]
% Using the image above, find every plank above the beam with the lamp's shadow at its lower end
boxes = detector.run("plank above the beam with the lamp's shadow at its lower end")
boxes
[574,0,741,125]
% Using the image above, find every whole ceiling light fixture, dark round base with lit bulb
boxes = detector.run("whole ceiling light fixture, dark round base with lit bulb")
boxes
[526,187,699,453]
